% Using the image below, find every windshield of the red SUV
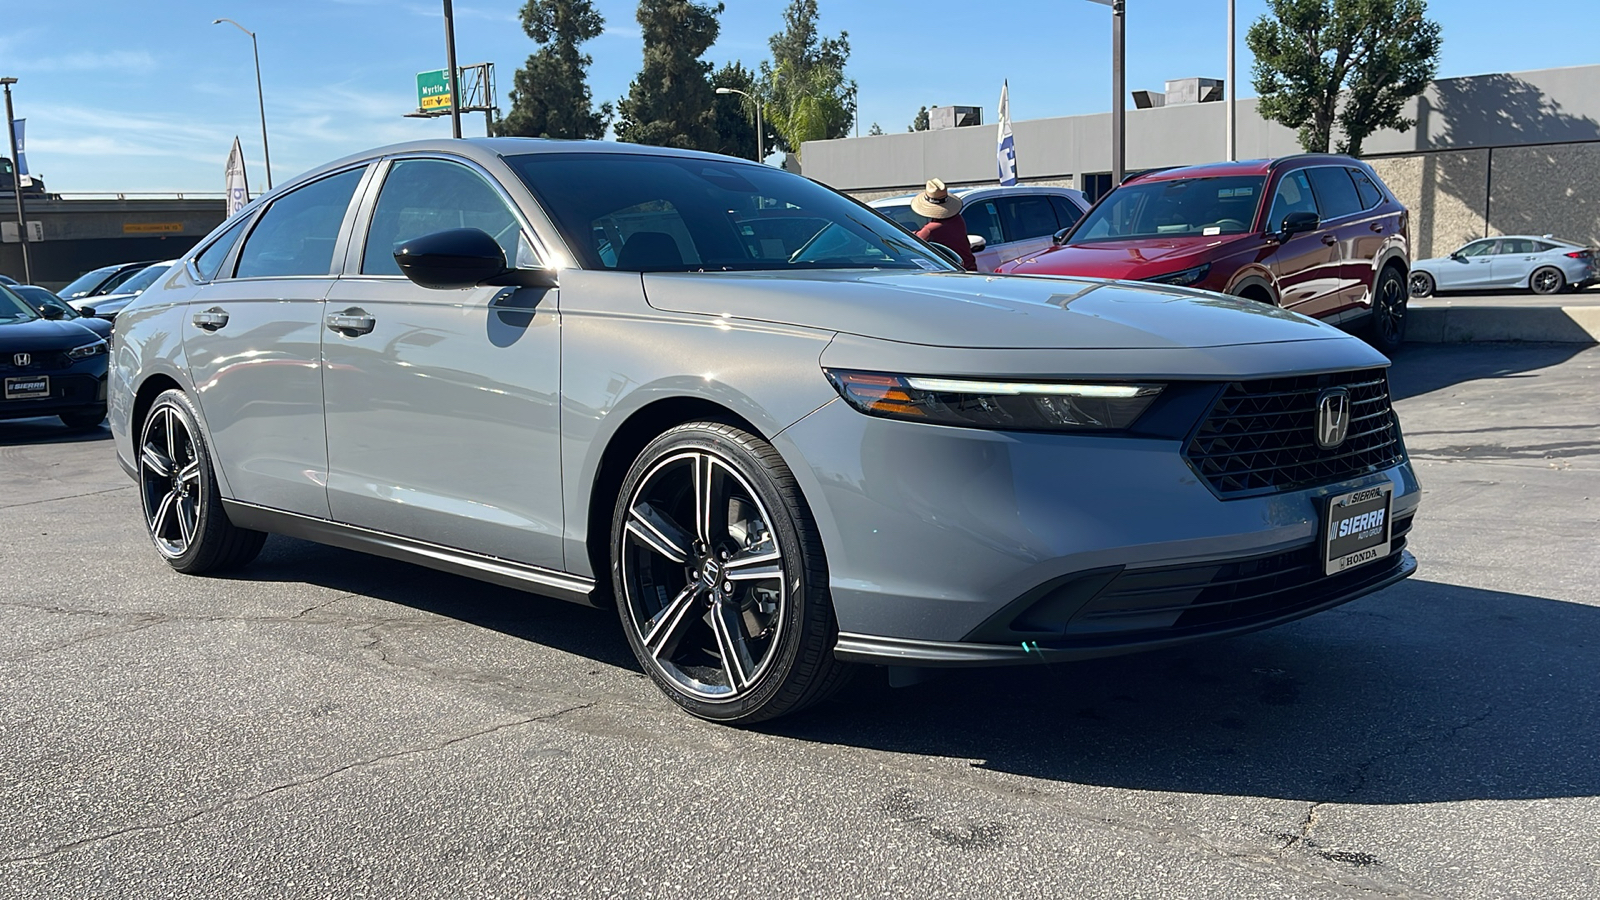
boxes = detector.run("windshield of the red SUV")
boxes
[1070,175,1266,243]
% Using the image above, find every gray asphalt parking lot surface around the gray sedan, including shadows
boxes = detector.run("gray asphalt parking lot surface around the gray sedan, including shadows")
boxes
[0,344,1600,898]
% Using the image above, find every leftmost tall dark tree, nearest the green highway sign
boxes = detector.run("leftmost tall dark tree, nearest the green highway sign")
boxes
[494,0,611,138]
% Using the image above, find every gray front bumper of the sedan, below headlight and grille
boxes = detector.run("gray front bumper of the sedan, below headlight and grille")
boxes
[776,395,1419,665]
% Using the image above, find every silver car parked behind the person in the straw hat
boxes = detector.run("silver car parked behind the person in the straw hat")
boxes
[867,186,1090,272]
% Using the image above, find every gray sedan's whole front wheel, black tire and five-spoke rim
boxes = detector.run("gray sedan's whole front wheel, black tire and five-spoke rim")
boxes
[611,421,853,724]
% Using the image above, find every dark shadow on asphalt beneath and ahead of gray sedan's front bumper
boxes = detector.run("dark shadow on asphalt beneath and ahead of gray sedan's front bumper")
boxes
[766,581,1600,804]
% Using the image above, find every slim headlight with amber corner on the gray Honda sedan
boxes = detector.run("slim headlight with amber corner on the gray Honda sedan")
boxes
[824,368,1162,431]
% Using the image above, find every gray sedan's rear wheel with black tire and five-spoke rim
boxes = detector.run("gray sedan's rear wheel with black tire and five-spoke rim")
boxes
[134,391,267,575]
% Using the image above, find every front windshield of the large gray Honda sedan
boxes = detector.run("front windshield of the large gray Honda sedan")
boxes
[506,154,958,272]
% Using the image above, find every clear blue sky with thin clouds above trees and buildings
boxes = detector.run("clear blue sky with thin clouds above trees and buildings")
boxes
[0,0,1600,191]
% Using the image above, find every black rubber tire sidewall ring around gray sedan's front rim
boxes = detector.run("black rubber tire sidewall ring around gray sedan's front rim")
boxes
[611,423,826,722]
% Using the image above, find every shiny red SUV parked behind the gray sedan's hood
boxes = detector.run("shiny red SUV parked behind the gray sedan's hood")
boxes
[997,154,1410,351]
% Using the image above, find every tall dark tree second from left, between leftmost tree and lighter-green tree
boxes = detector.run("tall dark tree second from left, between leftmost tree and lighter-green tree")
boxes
[616,0,723,151]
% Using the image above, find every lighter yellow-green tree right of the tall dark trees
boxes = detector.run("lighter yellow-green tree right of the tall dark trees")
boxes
[762,0,856,152]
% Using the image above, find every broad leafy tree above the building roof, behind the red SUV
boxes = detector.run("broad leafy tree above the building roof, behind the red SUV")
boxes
[1245,0,1440,155]
